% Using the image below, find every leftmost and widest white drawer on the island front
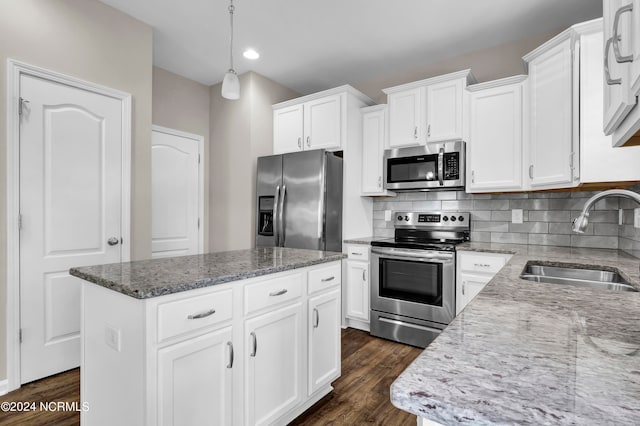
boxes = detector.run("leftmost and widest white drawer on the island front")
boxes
[158,289,233,342]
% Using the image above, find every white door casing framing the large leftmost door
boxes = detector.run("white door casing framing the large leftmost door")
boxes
[6,59,131,391]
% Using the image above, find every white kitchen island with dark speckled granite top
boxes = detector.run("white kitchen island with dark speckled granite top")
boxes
[70,247,344,426]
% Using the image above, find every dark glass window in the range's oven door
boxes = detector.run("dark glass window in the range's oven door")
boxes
[379,258,442,306]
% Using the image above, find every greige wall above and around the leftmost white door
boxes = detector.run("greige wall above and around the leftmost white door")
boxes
[0,0,152,380]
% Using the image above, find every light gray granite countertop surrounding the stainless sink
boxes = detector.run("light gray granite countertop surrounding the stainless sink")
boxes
[391,242,640,425]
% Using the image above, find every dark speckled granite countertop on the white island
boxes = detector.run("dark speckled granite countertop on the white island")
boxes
[69,247,345,299]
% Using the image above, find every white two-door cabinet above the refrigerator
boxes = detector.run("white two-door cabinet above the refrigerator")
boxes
[273,94,342,154]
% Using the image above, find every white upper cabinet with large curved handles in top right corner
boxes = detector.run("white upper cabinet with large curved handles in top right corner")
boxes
[602,0,640,146]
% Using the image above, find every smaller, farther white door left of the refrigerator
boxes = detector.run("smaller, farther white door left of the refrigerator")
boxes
[151,129,202,258]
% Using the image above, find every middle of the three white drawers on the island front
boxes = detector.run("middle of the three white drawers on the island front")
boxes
[244,273,302,314]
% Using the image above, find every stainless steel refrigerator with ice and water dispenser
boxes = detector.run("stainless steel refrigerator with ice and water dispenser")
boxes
[256,150,342,252]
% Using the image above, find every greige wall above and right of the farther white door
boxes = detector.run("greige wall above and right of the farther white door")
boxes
[152,67,211,252]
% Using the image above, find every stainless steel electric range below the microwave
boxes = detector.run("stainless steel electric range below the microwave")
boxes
[371,211,470,348]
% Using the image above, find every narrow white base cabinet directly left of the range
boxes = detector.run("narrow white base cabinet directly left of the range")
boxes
[344,244,370,331]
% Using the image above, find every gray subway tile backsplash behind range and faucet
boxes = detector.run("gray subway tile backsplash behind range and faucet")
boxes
[373,191,624,251]
